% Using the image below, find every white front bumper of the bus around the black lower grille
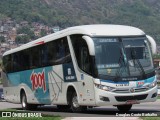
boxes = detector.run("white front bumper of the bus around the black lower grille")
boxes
[95,86,157,106]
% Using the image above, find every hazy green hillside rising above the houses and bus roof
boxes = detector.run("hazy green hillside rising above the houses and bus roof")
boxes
[0,0,160,41]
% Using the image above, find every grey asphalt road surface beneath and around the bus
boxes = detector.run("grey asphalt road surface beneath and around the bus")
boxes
[0,100,160,117]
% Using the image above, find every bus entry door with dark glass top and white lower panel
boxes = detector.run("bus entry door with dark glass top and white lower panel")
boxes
[71,35,95,105]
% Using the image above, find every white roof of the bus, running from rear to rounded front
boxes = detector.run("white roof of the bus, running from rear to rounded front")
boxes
[3,24,145,56]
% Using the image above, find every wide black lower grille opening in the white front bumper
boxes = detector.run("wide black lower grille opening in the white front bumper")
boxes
[115,94,148,102]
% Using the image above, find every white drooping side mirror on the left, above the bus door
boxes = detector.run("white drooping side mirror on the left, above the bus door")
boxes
[82,36,95,55]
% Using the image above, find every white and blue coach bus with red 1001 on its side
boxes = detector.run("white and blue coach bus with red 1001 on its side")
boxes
[3,24,157,112]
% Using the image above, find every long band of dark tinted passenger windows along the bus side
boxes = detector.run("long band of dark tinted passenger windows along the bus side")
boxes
[3,38,71,73]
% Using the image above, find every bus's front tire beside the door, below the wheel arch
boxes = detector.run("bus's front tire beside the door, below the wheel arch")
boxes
[70,92,87,112]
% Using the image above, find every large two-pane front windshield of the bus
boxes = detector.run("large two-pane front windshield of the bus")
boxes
[93,37,153,78]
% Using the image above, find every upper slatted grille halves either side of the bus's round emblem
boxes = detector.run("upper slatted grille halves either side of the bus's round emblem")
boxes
[112,87,148,93]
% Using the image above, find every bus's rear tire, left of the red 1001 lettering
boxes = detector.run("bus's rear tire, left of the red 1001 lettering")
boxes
[21,92,37,110]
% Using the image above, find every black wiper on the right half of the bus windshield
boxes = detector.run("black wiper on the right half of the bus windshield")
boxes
[131,48,146,79]
